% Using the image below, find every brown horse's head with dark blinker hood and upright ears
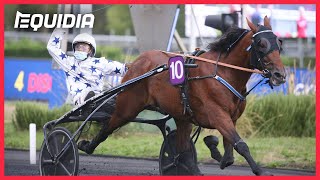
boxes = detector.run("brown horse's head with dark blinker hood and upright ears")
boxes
[247,16,286,86]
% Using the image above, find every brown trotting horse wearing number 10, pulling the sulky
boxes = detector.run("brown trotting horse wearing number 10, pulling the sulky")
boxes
[77,17,286,175]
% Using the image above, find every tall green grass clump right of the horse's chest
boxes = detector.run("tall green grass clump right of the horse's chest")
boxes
[238,93,316,137]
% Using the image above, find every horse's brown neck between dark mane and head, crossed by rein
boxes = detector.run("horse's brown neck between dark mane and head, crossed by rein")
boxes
[221,32,252,91]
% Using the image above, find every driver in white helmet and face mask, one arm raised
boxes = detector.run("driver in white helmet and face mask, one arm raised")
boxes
[47,29,128,106]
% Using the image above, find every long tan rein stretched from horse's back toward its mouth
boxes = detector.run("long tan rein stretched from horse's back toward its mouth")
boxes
[158,50,263,74]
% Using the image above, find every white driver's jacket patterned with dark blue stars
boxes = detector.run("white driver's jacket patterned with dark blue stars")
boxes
[47,29,126,105]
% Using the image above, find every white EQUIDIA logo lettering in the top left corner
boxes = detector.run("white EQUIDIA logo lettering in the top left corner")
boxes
[14,11,94,31]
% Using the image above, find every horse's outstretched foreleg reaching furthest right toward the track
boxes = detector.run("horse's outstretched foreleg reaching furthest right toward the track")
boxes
[216,119,271,176]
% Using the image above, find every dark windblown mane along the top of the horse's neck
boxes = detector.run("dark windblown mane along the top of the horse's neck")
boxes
[207,27,246,53]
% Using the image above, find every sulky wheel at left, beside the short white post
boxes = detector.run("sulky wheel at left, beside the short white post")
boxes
[39,127,79,176]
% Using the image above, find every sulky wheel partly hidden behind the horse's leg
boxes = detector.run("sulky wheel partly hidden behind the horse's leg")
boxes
[159,130,197,175]
